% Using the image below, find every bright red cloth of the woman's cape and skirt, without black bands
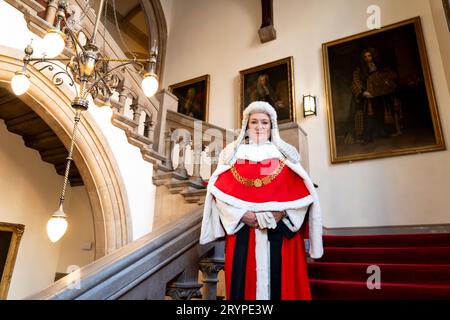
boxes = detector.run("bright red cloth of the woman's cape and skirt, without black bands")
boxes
[214,159,311,300]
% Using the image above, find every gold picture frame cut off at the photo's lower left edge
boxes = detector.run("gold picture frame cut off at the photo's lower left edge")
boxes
[0,222,25,300]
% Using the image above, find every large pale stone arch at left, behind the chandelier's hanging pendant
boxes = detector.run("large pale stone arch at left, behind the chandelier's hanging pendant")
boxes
[0,46,132,259]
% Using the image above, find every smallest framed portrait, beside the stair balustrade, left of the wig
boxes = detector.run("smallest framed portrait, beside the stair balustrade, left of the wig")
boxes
[169,74,209,121]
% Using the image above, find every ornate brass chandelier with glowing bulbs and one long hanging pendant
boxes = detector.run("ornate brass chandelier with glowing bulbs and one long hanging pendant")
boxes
[11,0,158,242]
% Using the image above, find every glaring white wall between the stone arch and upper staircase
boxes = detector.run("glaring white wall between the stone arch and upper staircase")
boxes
[0,0,156,240]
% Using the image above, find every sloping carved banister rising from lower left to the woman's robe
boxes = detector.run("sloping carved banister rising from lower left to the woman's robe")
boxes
[26,208,224,300]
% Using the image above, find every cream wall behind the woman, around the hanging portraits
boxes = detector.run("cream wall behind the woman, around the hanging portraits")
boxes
[164,0,450,227]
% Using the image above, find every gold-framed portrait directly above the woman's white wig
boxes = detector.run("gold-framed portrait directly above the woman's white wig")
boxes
[238,57,295,123]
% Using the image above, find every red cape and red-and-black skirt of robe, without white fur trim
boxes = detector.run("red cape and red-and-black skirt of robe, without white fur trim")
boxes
[214,159,311,300]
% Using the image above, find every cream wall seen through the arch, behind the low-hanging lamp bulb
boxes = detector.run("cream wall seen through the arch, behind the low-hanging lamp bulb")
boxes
[0,120,94,299]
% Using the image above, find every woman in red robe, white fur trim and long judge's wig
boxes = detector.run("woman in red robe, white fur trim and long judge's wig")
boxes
[200,101,323,300]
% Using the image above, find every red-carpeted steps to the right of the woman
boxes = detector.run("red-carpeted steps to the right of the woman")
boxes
[308,233,450,300]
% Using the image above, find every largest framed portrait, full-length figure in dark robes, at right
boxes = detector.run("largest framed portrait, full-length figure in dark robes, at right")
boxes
[322,17,445,163]
